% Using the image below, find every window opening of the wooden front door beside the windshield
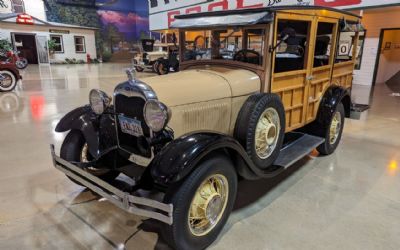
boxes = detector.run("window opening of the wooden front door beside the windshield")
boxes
[275,19,311,73]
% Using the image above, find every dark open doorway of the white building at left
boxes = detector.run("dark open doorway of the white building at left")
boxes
[13,33,39,64]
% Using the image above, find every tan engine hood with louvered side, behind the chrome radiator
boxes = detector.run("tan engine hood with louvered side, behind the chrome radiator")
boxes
[142,66,261,137]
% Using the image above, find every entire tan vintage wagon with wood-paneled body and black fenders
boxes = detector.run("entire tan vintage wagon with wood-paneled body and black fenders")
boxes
[52,6,362,249]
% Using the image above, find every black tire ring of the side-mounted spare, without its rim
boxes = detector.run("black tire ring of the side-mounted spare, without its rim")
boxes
[234,93,285,169]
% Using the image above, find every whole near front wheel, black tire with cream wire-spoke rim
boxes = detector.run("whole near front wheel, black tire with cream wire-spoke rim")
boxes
[163,156,237,249]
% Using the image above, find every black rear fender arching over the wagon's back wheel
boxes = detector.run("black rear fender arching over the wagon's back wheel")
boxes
[317,85,351,124]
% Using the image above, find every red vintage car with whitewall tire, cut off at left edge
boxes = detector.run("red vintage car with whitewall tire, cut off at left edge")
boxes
[0,62,22,92]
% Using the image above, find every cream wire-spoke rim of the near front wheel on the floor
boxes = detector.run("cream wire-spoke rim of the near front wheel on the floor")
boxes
[188,174,229,236]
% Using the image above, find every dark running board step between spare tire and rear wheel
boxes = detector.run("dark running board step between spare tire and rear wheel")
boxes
[273,134,325,168]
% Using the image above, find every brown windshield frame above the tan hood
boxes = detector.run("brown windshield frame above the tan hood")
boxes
[179,24,271,75]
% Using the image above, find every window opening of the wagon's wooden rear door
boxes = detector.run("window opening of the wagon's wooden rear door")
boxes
[314,22,335,68]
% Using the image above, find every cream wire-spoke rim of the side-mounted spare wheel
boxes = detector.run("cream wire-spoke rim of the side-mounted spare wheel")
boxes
[255,108,281,159]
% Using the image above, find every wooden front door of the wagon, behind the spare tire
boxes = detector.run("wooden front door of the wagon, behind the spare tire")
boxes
[271,13,316,132]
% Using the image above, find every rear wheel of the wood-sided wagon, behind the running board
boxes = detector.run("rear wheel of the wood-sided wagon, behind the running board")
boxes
[317,103,345,155]
